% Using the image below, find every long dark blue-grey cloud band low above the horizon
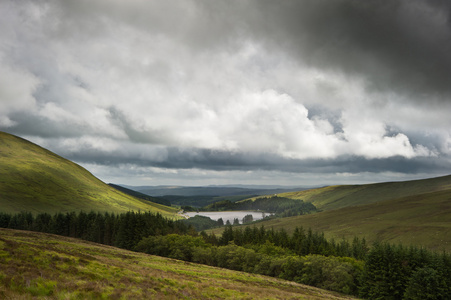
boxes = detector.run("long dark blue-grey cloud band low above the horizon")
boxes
[59,143,451,174]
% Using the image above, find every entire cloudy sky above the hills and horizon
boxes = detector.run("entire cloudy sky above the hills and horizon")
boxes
[0,0,451,186]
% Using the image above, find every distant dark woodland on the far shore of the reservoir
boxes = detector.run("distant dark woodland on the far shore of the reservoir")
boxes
[201,196,317,217]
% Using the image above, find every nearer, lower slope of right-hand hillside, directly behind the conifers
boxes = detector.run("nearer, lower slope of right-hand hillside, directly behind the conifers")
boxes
[213,189,451,252]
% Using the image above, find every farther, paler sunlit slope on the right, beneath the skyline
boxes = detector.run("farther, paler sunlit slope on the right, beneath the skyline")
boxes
[278,175,451,210]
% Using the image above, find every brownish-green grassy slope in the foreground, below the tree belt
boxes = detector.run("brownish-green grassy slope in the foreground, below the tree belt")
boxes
[0,229,349,299]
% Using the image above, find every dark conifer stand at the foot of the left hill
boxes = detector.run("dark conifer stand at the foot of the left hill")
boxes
[0,212,192,250]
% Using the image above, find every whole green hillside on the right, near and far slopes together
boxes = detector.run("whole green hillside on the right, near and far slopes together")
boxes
[212,176,451,251]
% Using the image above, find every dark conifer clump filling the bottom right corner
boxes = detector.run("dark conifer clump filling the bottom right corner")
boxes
[360,243,451,300]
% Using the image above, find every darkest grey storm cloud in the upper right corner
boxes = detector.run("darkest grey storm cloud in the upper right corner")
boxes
[247,0,451,101]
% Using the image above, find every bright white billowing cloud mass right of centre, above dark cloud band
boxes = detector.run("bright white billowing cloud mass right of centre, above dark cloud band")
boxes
[217,90,337,158]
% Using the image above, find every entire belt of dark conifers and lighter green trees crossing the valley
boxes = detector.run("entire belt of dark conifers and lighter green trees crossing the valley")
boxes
[0,212,451,299]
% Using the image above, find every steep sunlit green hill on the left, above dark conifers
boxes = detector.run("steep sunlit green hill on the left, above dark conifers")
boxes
[0,132,180,217]
